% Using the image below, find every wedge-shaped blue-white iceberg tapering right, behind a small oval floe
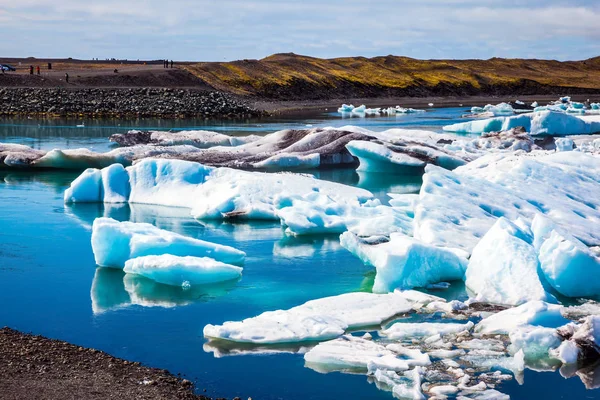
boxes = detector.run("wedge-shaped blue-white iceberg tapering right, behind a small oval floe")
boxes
[92,218,246,268]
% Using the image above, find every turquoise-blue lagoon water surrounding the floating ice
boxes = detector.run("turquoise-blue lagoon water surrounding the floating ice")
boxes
[0,109,600,400]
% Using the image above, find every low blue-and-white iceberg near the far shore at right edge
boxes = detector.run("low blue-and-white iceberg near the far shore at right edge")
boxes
[443,111,600,136]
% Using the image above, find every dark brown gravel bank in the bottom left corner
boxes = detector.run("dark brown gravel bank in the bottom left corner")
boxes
[0,328,219,400]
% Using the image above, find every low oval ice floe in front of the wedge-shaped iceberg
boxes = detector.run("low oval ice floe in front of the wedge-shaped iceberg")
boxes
[123,254,242,286]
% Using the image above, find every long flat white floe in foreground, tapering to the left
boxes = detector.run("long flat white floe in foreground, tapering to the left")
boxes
[204,293,414,344]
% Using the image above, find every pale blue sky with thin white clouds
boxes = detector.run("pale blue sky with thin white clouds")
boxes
[0,0,600,61]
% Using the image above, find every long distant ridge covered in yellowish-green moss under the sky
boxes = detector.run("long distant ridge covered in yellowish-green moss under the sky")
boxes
[185,53,600,100]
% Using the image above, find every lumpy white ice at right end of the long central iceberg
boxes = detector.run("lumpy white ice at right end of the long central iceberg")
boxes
[276,192,412,236]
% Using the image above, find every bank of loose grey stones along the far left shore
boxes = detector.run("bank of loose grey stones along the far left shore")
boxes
[0,88,264,119]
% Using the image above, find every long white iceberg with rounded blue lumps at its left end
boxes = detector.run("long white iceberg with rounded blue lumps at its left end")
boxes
[65,159,373,220]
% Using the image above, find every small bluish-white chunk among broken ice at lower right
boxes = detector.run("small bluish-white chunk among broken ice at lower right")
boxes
[509,326,562,360]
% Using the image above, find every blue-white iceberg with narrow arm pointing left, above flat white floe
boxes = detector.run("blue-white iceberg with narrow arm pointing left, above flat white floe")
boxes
[340,232,467,293]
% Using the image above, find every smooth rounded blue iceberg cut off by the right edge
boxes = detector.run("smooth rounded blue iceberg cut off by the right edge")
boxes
[533,216,600,297]
